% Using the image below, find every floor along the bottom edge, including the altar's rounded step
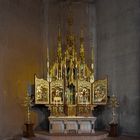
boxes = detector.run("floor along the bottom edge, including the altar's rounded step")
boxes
[8,132,140,140]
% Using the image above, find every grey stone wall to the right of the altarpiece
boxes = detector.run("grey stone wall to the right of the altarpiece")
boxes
[96,0,140,135]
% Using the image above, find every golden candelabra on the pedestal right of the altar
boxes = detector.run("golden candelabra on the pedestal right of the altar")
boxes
[109,94,119,124]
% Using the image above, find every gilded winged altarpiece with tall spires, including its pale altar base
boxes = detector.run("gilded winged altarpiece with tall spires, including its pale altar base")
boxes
[35,15,107,133]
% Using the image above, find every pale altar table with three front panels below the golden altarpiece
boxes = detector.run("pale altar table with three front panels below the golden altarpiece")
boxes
[49,116,96,134]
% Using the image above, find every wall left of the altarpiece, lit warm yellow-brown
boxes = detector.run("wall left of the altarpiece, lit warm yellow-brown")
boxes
[0,0,42,140]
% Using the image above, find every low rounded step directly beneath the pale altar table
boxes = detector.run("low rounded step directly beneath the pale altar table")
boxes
[22,131,108,140]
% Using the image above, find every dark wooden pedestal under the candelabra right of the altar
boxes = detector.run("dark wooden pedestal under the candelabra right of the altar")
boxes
[109,123,118,137]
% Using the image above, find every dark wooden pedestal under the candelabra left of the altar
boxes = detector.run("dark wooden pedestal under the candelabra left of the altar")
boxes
[23,123,35,138]
